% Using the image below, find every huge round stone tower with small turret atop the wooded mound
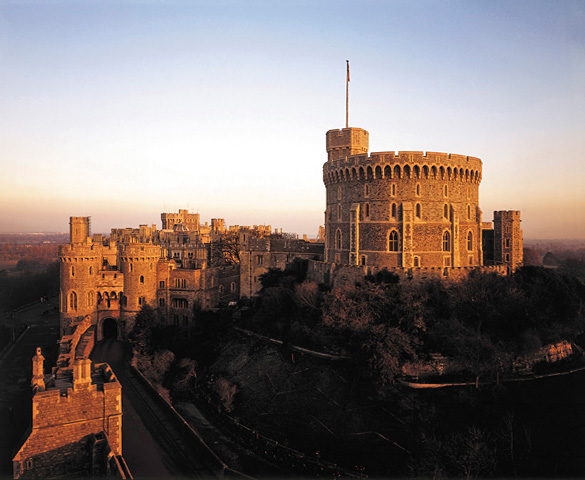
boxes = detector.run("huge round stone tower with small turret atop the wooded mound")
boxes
[323,128,482,268]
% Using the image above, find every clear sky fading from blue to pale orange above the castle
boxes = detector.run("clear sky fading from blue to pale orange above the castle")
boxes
[0,0,585,239]
